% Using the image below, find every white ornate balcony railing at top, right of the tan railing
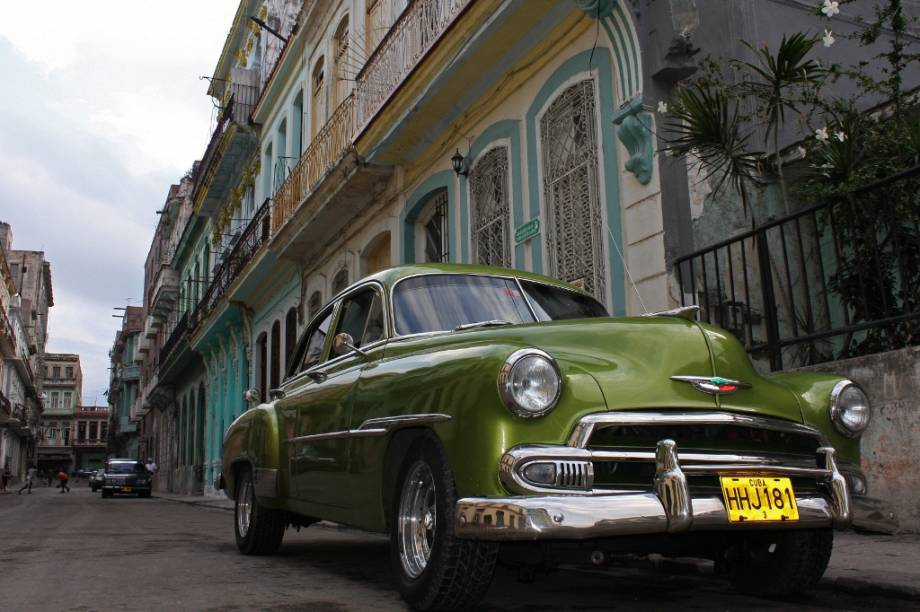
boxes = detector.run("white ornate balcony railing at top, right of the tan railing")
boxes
[355,0,473,129]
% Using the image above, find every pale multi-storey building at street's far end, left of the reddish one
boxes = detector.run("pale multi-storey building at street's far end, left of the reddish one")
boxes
[38,353,83,472]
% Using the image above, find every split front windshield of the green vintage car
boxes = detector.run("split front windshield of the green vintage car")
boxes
[393,274,607,335]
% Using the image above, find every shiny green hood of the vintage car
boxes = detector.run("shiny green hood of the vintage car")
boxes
[510,317,803,422]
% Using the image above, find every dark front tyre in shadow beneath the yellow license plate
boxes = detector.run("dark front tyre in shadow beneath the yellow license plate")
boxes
[718,529,834,596]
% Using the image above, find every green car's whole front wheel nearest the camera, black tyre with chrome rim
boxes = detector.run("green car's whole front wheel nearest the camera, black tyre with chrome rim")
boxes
[389,438,498,610]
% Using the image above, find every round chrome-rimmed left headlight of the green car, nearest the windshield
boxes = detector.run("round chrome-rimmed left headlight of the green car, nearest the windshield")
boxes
[498,349,562,419]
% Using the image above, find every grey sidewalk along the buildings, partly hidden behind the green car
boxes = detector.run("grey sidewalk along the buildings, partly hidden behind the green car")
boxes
[154,493,920,606]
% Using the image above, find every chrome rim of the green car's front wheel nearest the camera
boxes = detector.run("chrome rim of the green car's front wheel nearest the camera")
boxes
[396,461,437,578]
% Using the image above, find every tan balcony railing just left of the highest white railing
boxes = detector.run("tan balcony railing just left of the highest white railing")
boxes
[272,94,355,234]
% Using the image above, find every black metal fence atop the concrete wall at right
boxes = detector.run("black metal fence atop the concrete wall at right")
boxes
[675,166,920,370]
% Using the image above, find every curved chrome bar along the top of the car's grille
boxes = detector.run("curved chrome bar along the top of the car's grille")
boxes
[566,411,829,448]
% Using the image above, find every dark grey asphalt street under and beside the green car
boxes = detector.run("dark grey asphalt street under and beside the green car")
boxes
[0,485,914,612]
